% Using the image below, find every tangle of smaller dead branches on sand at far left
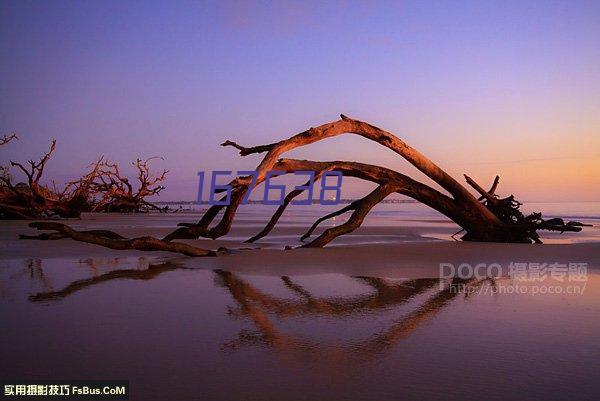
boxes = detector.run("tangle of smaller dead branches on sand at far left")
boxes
[0,134,168,219]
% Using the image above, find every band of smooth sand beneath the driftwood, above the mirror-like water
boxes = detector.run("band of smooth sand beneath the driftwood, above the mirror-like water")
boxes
[0,214,600,277]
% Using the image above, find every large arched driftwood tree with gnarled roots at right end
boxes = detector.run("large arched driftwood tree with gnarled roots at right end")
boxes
[21,115,583,255]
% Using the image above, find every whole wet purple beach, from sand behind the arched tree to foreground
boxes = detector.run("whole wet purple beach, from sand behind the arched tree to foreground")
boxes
[0,213,600,400]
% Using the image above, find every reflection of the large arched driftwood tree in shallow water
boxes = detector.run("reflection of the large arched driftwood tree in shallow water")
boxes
[215,270,494,362]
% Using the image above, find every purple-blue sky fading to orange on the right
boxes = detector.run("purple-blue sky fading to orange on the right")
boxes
[0,0,600,201]
